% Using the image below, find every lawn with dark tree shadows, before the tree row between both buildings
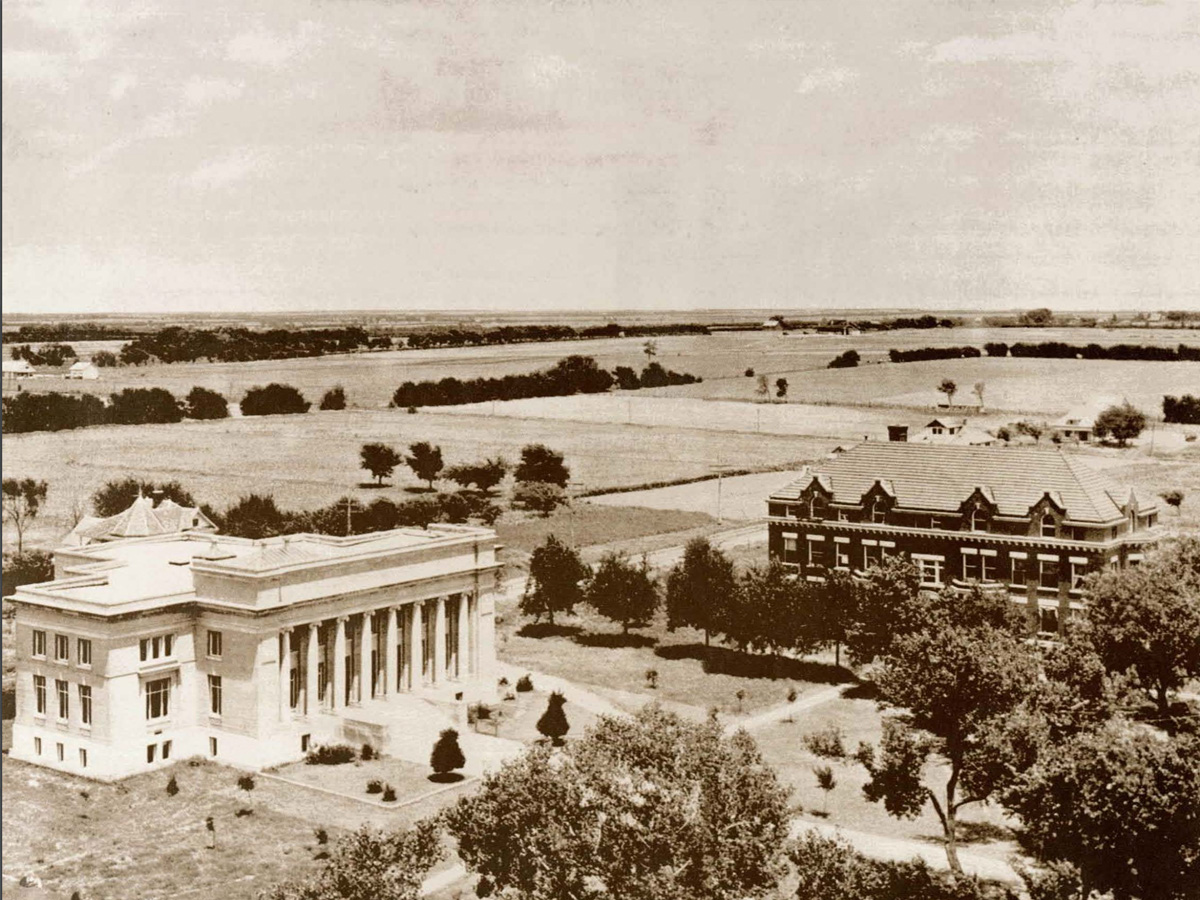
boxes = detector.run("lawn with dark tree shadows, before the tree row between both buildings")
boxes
[497,598,851,715]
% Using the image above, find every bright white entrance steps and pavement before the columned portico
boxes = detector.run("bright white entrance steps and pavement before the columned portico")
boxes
[342,694,524,775]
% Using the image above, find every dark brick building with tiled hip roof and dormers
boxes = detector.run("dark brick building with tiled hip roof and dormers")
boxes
[767,442,1158,632]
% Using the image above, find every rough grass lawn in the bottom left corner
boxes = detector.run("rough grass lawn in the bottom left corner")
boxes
[2,757,337,900]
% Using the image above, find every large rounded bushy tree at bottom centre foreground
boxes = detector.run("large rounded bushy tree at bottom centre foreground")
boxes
[445,704,788,900]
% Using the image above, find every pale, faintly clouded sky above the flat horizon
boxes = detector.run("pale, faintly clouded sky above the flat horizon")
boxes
[2,0,1200,313]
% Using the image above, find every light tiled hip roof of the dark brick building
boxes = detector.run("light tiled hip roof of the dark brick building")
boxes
[770,442,1154,523]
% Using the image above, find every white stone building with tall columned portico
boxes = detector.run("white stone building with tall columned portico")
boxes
[11,499,498,779]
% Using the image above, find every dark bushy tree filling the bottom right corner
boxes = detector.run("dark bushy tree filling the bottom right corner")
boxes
[1004,721,1200,900]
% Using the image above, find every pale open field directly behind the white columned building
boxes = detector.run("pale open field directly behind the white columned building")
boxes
[4,410,829,554]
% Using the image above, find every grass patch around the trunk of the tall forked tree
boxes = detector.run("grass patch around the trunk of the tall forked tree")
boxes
[754,691,1016,856]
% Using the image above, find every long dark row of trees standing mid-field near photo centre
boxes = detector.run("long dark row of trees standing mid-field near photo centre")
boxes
[391,356,701,408]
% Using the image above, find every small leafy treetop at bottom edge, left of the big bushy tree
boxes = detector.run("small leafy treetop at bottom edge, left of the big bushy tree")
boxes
[263,818,445,900]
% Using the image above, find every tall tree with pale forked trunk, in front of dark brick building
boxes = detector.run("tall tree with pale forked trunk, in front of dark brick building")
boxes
[858,625,1038,875]
